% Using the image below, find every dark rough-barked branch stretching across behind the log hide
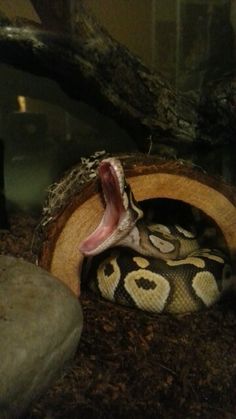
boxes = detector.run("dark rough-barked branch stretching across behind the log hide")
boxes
[0,5,236,151]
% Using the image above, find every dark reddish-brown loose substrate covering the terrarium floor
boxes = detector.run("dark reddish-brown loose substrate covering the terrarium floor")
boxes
[0,215,236,419]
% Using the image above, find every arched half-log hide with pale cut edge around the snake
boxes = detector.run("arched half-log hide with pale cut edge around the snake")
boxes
[37,155,236,295]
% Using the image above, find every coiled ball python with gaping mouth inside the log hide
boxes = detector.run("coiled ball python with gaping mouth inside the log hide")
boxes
[80,158,231,313]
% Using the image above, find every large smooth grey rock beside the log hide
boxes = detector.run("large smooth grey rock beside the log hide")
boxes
[0,256,83,419]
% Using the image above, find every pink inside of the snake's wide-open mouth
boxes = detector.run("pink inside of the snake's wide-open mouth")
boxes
[80,162,124,255]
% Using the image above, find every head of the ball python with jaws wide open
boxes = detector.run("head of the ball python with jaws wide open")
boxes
[80,158,143,256]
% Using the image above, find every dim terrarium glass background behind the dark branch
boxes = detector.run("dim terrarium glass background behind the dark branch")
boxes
[0,0,233,217]
